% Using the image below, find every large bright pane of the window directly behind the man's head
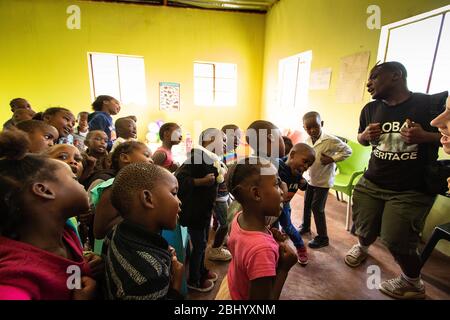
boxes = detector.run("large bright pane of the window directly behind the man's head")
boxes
[386,15,442,92]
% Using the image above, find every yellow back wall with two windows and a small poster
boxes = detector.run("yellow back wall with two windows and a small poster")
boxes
[0,0,265,138]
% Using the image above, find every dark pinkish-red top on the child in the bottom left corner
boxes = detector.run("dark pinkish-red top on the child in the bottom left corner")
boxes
[0,226,92,300]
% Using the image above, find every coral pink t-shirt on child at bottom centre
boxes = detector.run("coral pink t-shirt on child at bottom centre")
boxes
[227,212,279,300]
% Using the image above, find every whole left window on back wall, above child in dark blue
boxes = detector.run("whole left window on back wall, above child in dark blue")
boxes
[89,53,147,105]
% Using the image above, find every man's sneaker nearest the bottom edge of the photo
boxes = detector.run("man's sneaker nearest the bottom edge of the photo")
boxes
[380,275,425,300]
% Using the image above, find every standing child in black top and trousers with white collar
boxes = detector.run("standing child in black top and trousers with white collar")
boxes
[175,128,226,292]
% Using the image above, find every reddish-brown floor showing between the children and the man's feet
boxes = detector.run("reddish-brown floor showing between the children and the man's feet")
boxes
[188,192,450,300]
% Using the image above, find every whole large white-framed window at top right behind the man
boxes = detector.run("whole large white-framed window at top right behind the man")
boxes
[378,6,450,94]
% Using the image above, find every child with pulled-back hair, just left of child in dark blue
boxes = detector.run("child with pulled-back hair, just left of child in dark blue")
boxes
[40,107,75,144]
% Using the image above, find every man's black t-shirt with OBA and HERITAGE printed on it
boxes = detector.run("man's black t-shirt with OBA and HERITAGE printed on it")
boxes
[358,93,444,191]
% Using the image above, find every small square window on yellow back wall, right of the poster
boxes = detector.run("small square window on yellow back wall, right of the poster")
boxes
[194,62,237,106]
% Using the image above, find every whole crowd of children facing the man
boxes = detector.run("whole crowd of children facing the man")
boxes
[0,96,351,300]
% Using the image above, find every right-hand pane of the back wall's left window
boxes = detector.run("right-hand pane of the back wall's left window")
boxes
[119,57,147,106]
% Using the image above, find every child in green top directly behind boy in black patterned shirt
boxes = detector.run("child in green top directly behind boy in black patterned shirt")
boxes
[90,141,153,239]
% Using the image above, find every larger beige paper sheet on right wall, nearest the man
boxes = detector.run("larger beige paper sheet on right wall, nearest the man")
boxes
[336,51,370,103]
